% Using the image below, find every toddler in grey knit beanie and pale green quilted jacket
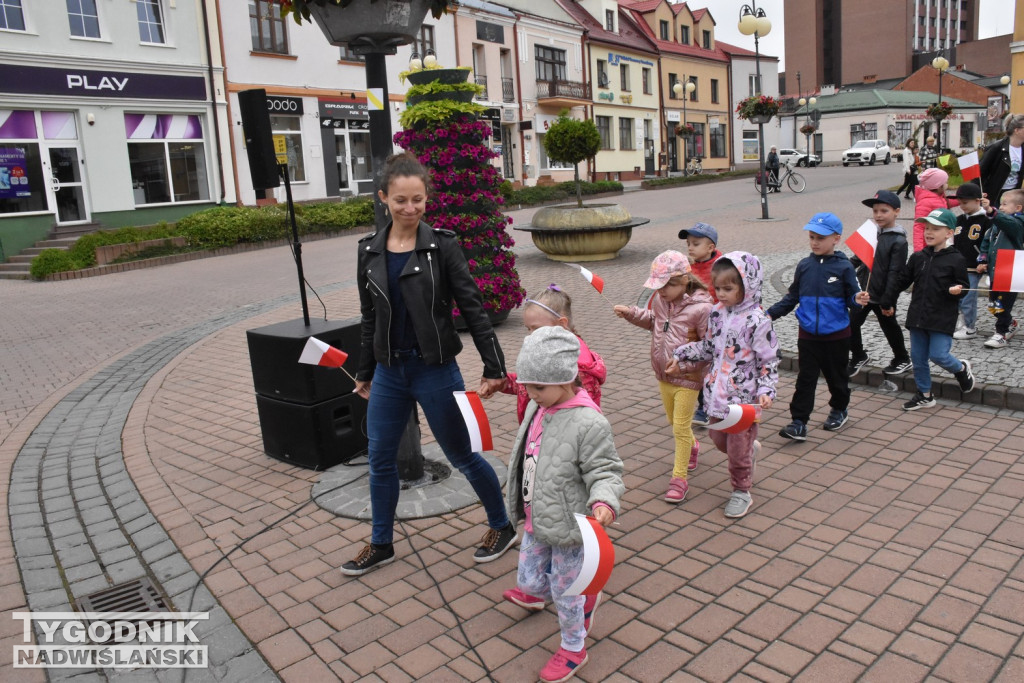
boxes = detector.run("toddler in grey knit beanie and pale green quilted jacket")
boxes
[503,326,625,681]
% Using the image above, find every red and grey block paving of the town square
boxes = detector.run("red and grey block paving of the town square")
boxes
[0,169,1024,681]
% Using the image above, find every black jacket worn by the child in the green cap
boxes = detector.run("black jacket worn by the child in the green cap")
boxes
[899,247,970,335]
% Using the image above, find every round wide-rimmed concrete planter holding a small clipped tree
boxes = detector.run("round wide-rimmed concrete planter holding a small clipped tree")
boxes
[514,204,648,262]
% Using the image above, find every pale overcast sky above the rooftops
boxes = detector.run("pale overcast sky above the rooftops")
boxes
[708,0,1014,71]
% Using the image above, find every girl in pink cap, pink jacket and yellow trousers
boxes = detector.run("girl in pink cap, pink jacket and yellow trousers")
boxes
[614,251,712,503]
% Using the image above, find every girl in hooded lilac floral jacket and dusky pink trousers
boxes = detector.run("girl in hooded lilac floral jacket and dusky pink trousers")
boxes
[669,251,779,518]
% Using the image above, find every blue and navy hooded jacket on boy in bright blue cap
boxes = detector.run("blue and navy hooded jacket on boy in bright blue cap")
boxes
[768,252,860,337]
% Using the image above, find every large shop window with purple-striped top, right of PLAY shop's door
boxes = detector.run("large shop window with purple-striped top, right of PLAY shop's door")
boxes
[125,114,210,206]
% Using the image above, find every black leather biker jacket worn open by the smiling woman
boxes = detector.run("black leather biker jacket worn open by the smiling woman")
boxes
[355,221,506,382]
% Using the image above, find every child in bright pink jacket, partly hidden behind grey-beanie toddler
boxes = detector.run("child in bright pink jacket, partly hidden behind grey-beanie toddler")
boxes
[501,285,608,424]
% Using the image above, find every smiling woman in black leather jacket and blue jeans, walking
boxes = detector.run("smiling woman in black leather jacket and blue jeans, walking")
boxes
[341,154,516,575]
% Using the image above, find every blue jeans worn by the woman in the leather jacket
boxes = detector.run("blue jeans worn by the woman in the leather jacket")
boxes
[367,355,509,545]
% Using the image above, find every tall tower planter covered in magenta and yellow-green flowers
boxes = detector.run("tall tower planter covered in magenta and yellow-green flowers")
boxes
[394,69,525,324]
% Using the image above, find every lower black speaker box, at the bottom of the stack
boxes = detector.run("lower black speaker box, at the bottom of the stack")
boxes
[256,393,368,470]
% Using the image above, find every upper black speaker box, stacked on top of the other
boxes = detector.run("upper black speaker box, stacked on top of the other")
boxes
[246,317,362,405]
